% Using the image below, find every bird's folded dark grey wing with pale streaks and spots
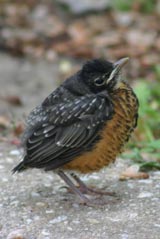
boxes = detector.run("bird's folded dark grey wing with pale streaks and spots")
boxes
[24,95,113,169]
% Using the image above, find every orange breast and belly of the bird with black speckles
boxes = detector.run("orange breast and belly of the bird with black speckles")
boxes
[63,88,137,173]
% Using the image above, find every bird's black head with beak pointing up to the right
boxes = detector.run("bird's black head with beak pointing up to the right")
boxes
[80,58,129,93]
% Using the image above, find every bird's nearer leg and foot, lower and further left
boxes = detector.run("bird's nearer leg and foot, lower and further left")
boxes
[57,170,105,206]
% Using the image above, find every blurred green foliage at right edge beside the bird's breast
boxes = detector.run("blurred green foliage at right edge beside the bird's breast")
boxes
[123,65,160,170]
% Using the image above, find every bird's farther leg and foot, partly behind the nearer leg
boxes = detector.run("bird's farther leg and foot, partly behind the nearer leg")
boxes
[71,173,115,196]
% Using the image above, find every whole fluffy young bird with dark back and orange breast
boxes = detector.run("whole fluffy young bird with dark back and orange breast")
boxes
[12,57,139,205]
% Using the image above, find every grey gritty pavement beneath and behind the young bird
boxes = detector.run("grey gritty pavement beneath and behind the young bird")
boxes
[0,54,160,239]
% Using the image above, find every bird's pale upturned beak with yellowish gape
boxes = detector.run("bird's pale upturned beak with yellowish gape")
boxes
[107,57,129,83]
